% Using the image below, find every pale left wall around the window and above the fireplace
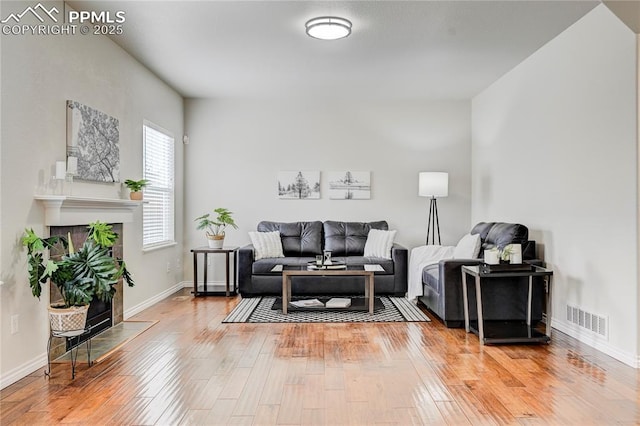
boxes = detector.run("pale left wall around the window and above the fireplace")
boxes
[0,2,183,386]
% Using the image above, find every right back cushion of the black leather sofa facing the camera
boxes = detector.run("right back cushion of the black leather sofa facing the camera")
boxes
[323,220,389,256]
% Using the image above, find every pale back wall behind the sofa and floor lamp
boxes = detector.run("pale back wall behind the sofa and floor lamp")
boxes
[185,99,470,280]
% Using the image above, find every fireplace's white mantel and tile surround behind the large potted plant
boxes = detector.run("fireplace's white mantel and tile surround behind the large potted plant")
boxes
[34,195,142,359]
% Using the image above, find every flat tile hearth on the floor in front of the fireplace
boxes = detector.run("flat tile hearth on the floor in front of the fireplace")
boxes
[53,321,158,362]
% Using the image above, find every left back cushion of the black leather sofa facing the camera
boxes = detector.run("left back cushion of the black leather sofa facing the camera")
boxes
[258,221,322,256]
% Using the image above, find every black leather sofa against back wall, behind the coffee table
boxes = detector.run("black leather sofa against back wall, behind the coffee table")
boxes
[236,221,408,297]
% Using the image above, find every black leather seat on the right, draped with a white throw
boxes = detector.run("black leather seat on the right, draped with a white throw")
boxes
[418,222,544,328]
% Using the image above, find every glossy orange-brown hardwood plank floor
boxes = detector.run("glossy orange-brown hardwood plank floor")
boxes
[0,289,640,425]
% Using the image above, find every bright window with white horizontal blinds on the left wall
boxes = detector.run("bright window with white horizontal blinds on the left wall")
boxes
[142,121,174,249]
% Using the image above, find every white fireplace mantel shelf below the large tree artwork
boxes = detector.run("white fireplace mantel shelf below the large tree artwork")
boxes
[33,195,142,226]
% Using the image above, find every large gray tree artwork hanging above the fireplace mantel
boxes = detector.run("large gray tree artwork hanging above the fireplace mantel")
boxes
[67,101,120,182]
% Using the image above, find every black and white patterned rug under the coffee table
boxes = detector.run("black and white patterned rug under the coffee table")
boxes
[222,296,430,323]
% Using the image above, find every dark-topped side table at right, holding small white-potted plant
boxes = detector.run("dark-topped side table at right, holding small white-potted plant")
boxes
[462,265,553,344]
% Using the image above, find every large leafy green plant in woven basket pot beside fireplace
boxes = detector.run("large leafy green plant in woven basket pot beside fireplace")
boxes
[22,221,134,331]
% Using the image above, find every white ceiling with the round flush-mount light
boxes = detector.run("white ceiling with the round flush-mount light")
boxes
[68,0,600,99]
